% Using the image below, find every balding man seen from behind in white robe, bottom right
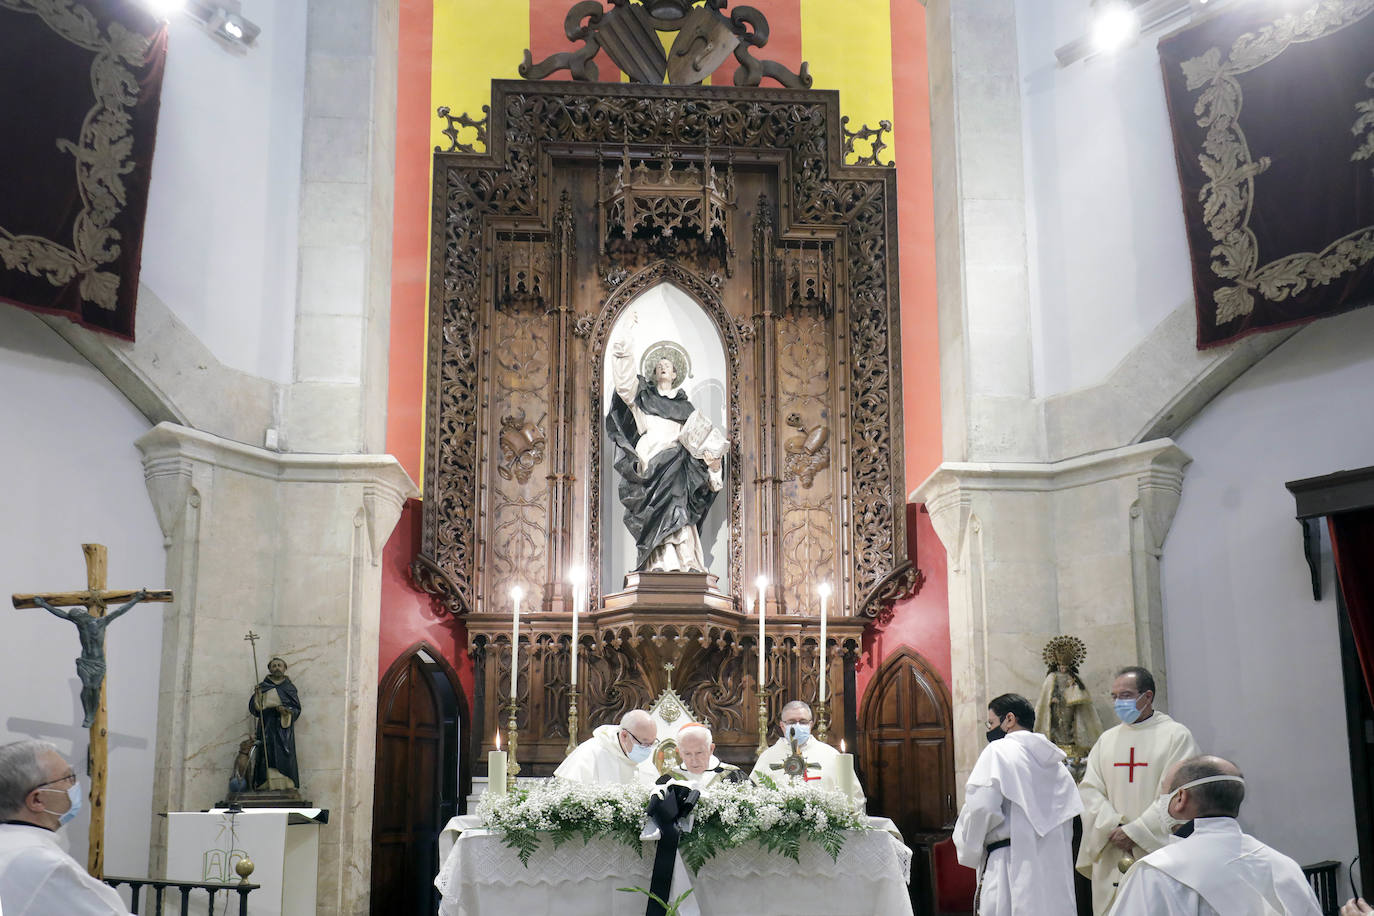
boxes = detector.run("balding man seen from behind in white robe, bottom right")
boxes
[1112,757,1322,916]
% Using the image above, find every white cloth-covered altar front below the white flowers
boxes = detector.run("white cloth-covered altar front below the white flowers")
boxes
[434,829,911,916]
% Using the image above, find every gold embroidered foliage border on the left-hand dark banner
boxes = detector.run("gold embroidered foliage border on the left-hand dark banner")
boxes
[0,0,151,312]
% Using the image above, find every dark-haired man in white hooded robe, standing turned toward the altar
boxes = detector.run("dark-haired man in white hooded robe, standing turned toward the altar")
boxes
[952,694,1083,916]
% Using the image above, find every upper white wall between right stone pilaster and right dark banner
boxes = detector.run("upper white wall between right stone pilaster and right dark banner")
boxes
[1015,0,1193,397]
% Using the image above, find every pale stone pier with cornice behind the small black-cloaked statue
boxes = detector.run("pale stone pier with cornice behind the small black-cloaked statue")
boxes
[137,423,418,916]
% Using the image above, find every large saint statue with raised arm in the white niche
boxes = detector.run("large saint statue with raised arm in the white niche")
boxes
[606,312,730,573]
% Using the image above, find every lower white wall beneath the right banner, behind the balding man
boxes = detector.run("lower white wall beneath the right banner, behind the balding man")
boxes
[1162,309,1374,895]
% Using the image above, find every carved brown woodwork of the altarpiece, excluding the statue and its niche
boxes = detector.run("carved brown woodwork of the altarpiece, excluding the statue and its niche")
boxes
[412,80,919,773]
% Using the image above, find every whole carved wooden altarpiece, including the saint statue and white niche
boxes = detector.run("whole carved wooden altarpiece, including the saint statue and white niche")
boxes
[412,43,919,775]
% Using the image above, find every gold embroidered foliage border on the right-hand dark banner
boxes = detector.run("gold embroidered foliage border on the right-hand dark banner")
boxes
[1180,0,1374,324]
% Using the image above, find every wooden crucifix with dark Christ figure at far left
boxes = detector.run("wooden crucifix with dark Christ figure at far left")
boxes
[10,544,172,878]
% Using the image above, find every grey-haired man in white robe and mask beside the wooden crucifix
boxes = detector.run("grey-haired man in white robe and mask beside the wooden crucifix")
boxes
[0,740,129,916]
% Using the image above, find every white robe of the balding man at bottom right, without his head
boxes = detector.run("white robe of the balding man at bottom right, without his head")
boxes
[1112,817,1322,916]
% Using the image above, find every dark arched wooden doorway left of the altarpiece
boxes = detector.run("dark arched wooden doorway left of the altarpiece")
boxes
[372,643,467,916]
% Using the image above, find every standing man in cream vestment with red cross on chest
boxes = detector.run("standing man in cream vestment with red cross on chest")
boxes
[1077,666,1200,916]
